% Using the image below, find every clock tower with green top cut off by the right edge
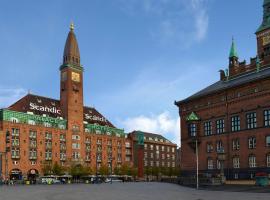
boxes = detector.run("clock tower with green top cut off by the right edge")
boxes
[256,0,270,65]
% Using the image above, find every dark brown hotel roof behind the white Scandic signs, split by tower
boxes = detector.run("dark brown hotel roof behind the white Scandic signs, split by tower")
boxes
[8,94,115,128]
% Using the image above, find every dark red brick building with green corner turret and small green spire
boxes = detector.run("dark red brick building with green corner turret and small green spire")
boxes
[175,0,270,179]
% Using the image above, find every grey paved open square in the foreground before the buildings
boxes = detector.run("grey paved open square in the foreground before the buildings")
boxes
[0,183,270,200]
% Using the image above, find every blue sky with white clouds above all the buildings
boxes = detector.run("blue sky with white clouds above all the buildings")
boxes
[0,0,263,145]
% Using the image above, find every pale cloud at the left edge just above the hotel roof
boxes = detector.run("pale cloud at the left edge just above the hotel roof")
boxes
[0,87,26,108]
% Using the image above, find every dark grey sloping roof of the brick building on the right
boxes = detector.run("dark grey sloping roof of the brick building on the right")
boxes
[175,67,270,105]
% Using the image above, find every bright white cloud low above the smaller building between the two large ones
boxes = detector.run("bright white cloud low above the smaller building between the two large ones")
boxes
[120,111,180,146]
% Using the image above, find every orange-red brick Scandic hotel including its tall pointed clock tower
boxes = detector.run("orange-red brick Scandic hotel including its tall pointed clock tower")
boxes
[0,25,129,179]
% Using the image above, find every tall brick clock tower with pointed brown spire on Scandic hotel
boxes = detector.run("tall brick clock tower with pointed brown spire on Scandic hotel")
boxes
[60,23,84,161]
